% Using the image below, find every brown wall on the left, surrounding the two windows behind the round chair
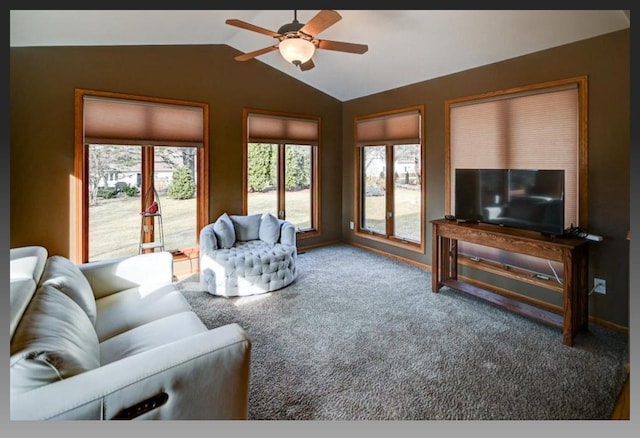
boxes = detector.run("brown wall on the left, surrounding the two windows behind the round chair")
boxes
[10,46,342,256]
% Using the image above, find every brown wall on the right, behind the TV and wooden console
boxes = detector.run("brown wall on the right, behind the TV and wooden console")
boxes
[342,29,630,327]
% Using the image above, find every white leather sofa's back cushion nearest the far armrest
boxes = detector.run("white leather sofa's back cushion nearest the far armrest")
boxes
[40,256,96,326]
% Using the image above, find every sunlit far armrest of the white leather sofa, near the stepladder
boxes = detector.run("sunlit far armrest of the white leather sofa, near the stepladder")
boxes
[78,251,173,298]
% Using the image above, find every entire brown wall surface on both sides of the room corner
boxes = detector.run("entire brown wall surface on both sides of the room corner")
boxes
[10,30,630,327]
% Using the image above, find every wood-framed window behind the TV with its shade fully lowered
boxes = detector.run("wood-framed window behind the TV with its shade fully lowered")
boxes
[445,77,587,276]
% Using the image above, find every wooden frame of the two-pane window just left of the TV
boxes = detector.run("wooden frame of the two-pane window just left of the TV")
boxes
[353,105,427,254]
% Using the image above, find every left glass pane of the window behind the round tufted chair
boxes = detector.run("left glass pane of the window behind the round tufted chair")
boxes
[247,143,278,217]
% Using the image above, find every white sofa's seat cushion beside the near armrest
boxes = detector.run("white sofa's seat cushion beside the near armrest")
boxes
[100,312,207,365]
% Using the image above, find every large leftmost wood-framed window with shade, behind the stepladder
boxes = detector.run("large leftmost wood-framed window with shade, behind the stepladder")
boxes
[74,90,208,262]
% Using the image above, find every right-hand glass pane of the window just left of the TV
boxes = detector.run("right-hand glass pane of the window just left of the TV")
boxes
[393,144,422,242]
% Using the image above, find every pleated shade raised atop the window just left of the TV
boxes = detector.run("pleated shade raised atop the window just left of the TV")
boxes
[356,111,420,146]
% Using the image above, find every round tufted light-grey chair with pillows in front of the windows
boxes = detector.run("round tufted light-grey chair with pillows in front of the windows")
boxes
[200,213,298,297]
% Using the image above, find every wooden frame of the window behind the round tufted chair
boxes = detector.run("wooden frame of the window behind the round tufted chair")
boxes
[242,108,322,240]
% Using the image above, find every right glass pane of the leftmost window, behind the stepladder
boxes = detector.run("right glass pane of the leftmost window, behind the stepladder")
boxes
[153,146,198,251]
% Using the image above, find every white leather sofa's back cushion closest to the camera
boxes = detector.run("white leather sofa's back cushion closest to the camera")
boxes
[10,285,100,394]
